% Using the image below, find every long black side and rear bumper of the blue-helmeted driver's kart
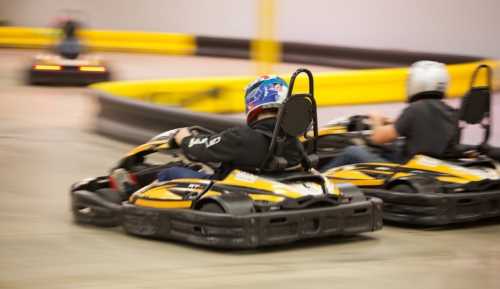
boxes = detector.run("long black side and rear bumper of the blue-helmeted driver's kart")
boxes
[122,198,382,249]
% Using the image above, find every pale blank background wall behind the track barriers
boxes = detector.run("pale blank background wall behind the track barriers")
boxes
[0,0,500,58]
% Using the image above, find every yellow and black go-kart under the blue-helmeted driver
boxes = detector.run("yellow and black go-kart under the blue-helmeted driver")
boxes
[71,69,382,248]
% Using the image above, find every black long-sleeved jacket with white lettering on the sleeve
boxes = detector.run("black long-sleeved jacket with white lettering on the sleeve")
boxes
[181,118,300,169]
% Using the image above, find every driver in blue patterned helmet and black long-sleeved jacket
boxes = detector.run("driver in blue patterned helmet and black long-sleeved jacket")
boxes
[153,76,300,181]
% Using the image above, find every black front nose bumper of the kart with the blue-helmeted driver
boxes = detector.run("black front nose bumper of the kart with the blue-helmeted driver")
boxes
[72,188,122,227]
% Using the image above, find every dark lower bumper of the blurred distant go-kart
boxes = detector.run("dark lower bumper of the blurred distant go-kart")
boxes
[28,69,111,86]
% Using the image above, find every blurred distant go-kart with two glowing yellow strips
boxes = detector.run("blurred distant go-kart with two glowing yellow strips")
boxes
[28,53,111,85]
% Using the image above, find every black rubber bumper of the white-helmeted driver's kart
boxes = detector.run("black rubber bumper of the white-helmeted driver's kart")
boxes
[363,189,500,226]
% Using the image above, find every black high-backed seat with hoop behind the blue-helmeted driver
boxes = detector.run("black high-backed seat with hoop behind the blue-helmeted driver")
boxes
[260,69,319,173]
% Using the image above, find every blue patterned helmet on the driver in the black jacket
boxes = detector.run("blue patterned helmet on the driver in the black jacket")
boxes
[245,75,288,123]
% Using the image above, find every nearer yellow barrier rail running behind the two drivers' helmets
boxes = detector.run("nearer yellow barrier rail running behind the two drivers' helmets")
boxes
[91,60,500,113]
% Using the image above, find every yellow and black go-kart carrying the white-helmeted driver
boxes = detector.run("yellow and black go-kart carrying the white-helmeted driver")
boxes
[317,65,500,226]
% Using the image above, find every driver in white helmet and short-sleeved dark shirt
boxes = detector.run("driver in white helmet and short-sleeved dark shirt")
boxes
[322,60,459,171]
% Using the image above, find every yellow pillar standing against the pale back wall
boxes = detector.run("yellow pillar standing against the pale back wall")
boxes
[251,0,281,75]
